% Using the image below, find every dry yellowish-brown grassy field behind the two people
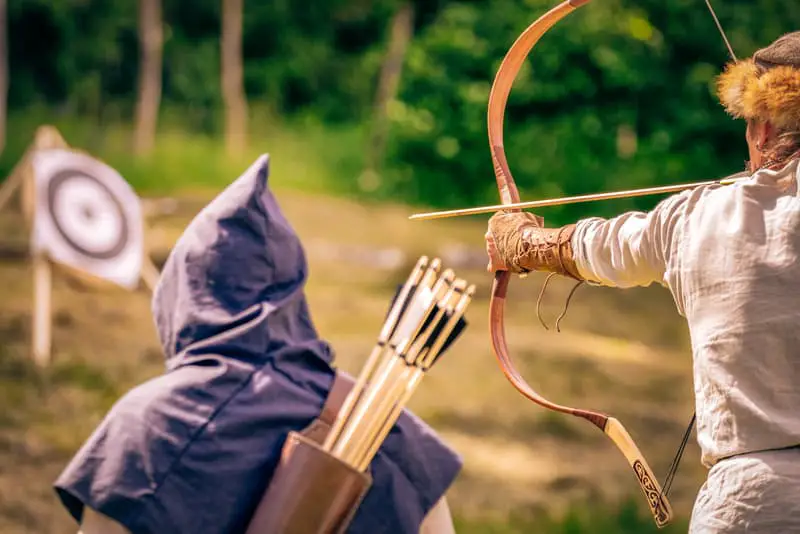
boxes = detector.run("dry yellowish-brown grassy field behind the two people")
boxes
[0,118,704,534]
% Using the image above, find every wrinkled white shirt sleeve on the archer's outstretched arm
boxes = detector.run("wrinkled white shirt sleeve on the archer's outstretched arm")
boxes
[572,193,687,288]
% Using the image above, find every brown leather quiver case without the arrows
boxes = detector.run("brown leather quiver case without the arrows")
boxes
[246,432,372,534]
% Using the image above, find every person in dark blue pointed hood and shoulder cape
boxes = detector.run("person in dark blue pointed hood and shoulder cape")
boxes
[55,156,461,534]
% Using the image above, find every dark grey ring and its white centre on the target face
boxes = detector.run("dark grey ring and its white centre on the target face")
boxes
[47,169,130,260]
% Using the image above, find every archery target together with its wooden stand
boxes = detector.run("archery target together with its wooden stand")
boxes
[0,126,159,366]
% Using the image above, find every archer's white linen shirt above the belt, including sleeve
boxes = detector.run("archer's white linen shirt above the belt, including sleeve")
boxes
[572,160,800,467]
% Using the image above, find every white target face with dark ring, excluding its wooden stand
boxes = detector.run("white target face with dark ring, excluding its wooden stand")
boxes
[32,149,144,289]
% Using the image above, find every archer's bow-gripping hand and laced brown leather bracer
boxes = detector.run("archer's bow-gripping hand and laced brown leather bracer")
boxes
[485,211,583,280]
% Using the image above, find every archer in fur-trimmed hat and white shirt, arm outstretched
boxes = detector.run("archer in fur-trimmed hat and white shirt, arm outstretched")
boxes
[486,32,800,534]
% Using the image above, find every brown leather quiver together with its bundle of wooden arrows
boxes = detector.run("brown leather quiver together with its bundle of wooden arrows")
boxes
[246,256,475,534]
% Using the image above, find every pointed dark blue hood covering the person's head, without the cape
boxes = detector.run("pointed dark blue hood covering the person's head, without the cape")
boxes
[152,155,331,368]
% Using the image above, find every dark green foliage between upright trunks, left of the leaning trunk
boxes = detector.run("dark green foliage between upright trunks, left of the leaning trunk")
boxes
[8,0,443,122]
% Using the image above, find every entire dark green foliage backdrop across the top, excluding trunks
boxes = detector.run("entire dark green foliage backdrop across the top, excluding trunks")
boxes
[8,0,800,221]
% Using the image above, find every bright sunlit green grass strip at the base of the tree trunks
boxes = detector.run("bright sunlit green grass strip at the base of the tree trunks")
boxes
[0,107,363,196]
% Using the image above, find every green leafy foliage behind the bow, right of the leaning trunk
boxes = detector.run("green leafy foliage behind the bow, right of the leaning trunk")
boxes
[384,0,800,220]
